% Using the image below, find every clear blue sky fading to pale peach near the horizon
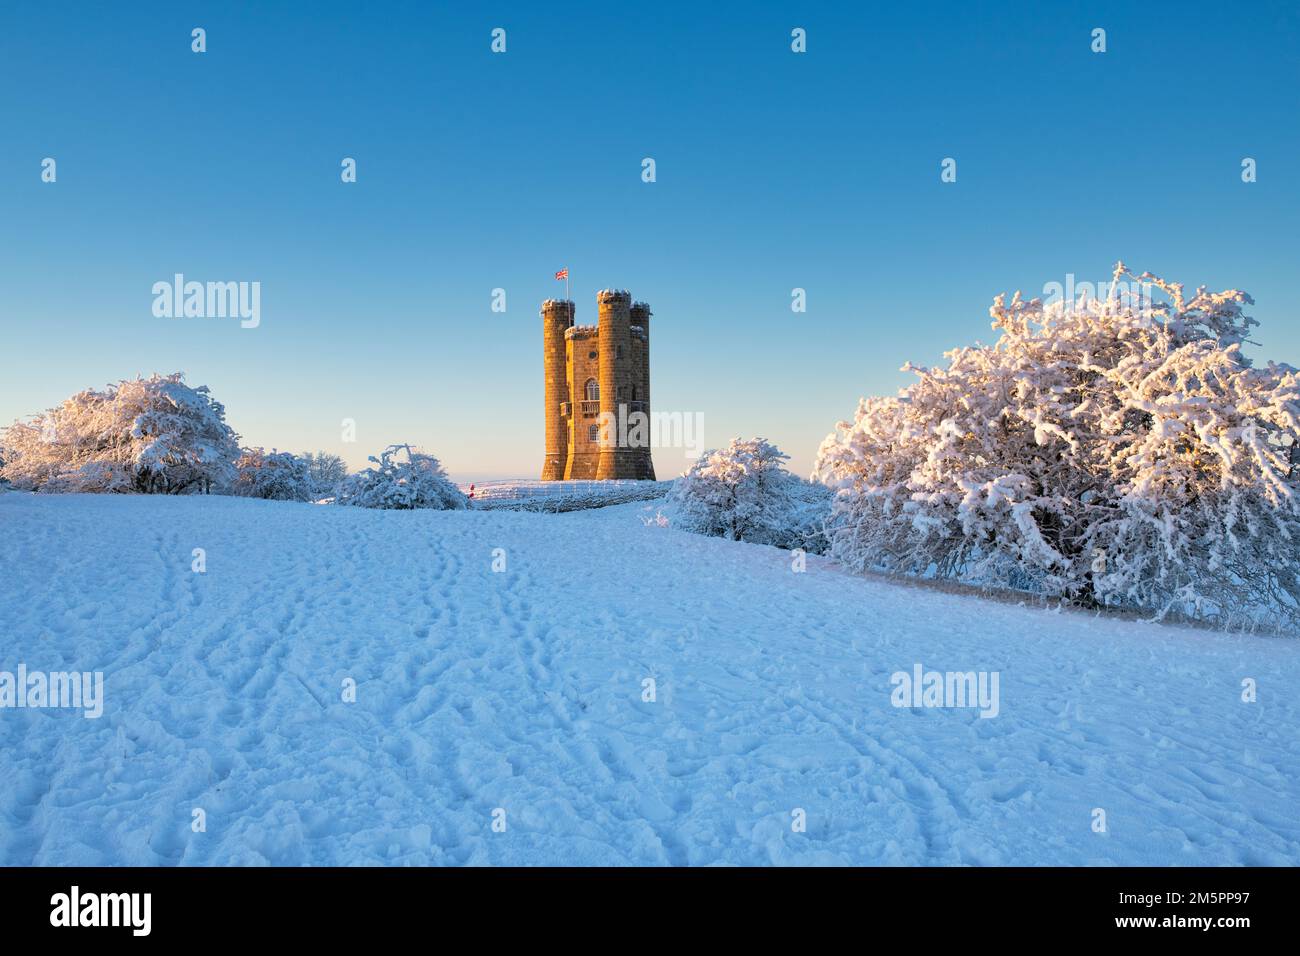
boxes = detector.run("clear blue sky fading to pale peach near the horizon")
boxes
[0,3,1300,477]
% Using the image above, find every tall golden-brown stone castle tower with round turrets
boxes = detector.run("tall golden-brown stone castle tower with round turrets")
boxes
[542,289,654,481]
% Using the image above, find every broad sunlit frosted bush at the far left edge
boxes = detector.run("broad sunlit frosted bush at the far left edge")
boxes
[0,372,239,494]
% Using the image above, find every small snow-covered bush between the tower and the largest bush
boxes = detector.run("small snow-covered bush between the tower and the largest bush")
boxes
[668,438,831,553]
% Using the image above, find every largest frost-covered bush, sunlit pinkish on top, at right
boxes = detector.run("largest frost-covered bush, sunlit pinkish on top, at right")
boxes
[815,263,1300,627]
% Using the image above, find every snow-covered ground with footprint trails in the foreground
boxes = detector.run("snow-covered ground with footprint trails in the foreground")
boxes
[0,493,1300,865]
